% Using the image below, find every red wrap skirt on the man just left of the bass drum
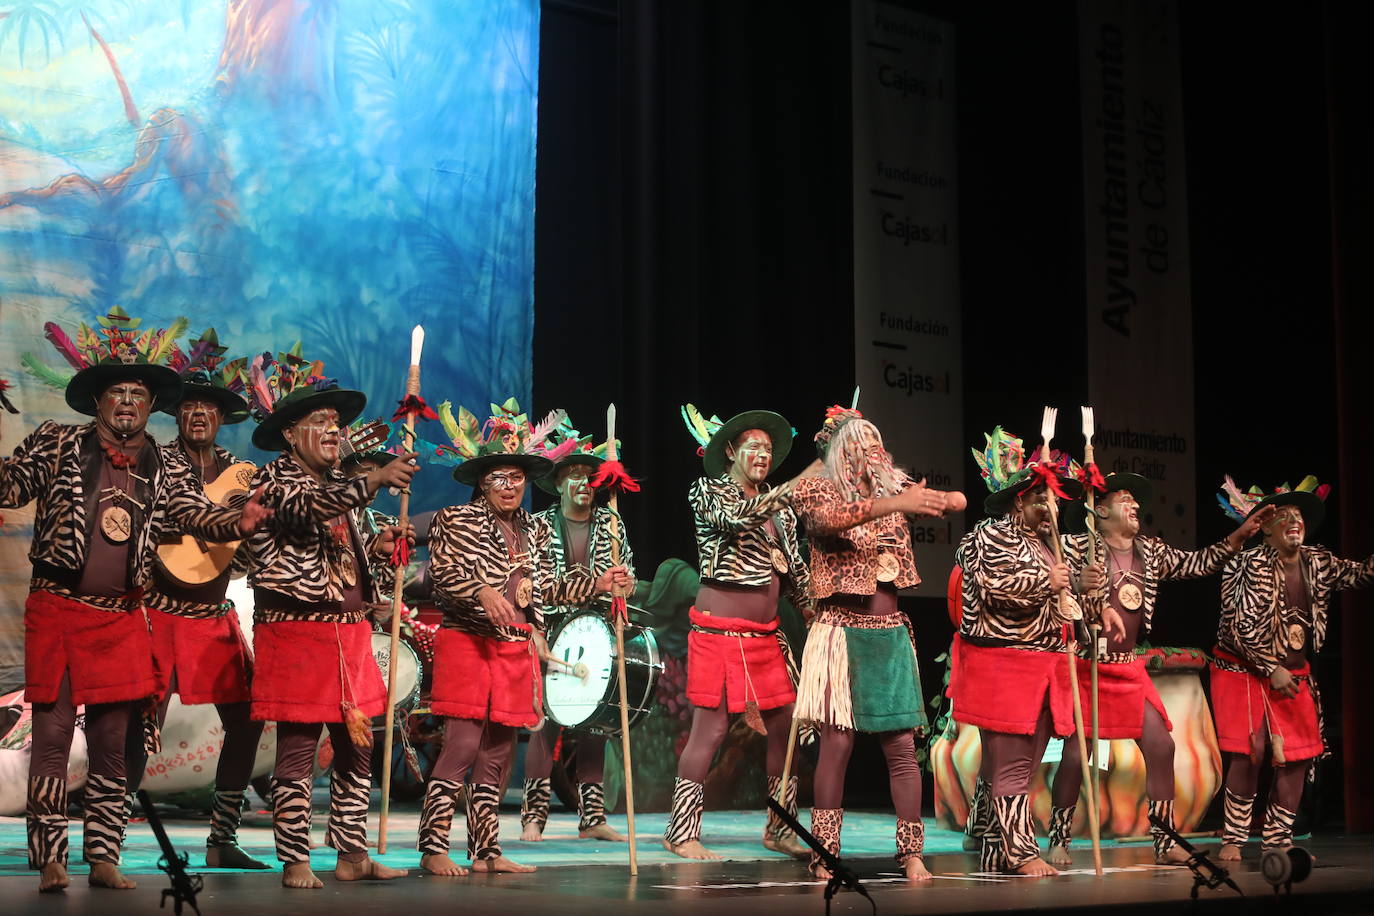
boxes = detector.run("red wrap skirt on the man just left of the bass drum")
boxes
[430,623,544,728]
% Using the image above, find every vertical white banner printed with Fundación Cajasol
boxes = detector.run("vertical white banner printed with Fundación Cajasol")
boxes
[851,0,961,597]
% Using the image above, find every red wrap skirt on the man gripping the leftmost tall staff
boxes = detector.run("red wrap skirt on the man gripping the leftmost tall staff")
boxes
[251,621,386,722]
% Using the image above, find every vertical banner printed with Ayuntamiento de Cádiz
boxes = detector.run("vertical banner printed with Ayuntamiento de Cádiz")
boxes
[1077,0,1197,545]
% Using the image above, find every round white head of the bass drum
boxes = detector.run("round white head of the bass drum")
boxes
[544,611,616,728]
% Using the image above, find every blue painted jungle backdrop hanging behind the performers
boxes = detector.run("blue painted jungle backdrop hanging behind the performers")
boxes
[0,0,539,684]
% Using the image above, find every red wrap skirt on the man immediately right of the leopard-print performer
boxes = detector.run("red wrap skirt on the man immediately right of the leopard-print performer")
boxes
[949,634,1073,737]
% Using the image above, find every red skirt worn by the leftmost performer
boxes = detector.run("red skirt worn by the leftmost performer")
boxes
[23,591,164,706]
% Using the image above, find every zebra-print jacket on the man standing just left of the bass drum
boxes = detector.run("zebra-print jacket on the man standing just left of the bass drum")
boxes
[429,500,595,643]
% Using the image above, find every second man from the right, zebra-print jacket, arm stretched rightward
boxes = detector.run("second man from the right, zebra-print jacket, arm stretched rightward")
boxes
[1048,466,1272,868]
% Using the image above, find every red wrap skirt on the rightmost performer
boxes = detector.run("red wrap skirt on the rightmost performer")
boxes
[1212,648,1325,764]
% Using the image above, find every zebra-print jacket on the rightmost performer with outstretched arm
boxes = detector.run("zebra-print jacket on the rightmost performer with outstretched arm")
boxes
[1216,544,1374,676]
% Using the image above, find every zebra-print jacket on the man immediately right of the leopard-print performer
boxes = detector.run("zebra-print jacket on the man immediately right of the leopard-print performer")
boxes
[955,515,1066,651]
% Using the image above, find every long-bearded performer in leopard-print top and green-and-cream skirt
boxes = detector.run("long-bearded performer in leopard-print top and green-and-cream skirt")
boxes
[793,407,966,880]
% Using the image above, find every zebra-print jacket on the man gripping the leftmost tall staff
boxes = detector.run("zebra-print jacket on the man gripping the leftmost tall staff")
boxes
[249,453,379,619]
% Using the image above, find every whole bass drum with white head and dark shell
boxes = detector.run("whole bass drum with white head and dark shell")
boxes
[544,610,664,736]
